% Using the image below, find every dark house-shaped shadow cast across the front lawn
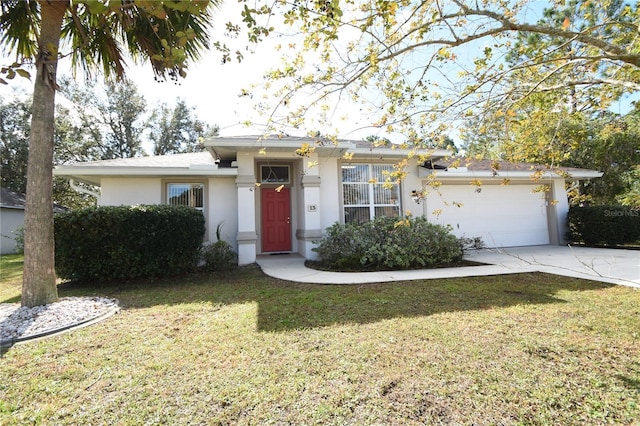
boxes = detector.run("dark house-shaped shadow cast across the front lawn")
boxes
[60,267,613,331]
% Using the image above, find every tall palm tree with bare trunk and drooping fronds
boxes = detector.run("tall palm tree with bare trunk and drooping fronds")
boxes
[0,0,216,306]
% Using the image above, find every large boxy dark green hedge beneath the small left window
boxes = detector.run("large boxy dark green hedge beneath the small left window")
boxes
[54,205,205,281]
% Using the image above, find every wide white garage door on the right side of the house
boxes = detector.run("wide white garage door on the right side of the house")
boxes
[424,184,549,247]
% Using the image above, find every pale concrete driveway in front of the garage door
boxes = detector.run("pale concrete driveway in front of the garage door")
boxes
[466,246,640,287]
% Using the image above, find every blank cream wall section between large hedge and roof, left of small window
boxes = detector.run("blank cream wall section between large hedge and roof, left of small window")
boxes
[99,178,162,206]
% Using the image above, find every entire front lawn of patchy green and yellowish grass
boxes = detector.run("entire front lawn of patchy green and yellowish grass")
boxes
[0,255,640,425]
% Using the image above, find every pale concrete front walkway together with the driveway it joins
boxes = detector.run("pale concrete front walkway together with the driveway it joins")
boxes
[257,246,640,288]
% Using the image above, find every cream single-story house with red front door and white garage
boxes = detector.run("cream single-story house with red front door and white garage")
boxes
[54,135,601,264]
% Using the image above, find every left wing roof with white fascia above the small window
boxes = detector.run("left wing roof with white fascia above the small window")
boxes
[53,151,237,185]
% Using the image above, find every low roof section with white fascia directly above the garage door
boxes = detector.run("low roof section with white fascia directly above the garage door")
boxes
[420,157,602,180]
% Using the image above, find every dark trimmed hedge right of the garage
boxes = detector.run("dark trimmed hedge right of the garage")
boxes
[567,206,640,246]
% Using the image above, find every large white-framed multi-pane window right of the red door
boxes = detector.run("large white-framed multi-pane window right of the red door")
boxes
[342,164,400,223]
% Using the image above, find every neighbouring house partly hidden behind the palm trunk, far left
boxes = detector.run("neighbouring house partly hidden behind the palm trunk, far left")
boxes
[0,188,67,254]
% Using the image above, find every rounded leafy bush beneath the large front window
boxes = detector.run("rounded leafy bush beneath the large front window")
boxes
[314,216,463,270]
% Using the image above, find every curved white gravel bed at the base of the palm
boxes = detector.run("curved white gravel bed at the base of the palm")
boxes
[0,297,120,348]
